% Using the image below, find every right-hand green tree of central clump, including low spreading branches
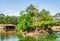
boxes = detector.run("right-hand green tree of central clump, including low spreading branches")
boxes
[40,9,58,29]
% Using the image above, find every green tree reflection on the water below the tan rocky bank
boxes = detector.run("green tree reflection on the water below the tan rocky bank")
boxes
[18,33,59,41]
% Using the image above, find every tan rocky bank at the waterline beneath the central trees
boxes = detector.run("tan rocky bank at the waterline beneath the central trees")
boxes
[20,30,48,37]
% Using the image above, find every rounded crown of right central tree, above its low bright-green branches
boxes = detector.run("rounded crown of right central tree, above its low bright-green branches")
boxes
[40,9,53,21]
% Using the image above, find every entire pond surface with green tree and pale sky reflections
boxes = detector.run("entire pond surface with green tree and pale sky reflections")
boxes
[0,32,60,41]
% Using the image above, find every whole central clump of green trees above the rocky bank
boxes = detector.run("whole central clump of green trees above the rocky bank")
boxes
[17,4,58,30]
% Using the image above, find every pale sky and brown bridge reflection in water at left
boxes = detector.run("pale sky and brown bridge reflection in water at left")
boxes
[0,33,18,41]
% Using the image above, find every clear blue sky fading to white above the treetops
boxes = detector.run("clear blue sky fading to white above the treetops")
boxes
[0,0,60,16]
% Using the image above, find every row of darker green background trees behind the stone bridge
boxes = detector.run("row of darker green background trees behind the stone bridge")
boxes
[0,14,18,24]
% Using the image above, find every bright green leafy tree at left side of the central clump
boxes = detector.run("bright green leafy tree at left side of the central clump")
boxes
[17,14,31,30]
